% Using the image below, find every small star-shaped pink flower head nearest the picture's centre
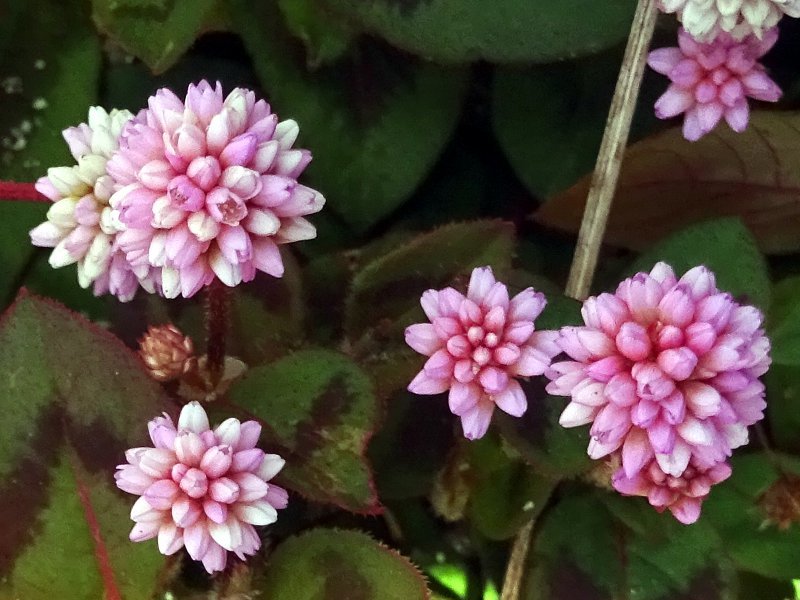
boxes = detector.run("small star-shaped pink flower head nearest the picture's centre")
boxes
[406,267,559,439]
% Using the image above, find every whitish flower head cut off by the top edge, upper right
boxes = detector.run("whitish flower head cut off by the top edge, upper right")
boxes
[658,0,800,42]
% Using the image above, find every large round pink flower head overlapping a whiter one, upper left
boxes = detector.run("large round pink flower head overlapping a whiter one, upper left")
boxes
[108,81,325,297]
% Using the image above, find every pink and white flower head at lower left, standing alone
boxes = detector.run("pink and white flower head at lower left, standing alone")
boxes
[114,402,288,573]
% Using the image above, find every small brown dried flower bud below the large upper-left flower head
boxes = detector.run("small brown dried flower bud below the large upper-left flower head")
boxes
[139,325,197,381]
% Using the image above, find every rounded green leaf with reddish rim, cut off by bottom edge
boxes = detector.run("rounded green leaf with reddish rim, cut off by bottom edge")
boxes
[261,529,430,600]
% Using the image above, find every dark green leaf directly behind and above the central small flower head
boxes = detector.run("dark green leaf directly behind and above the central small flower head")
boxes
[345,221,514,337]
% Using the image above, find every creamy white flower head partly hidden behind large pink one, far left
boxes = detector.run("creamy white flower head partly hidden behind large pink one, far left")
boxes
[30,106,145,301]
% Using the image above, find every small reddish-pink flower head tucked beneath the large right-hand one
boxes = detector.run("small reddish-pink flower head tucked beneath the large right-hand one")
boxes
[612,461,731,525]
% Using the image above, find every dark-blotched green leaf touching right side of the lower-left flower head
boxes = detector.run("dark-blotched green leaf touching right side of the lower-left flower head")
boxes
[229,350,380,514]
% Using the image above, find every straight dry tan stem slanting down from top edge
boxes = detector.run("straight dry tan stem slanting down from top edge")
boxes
[566,0,658,300]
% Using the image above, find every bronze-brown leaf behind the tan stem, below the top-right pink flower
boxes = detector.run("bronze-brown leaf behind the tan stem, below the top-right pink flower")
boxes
[535,111,800,254]
